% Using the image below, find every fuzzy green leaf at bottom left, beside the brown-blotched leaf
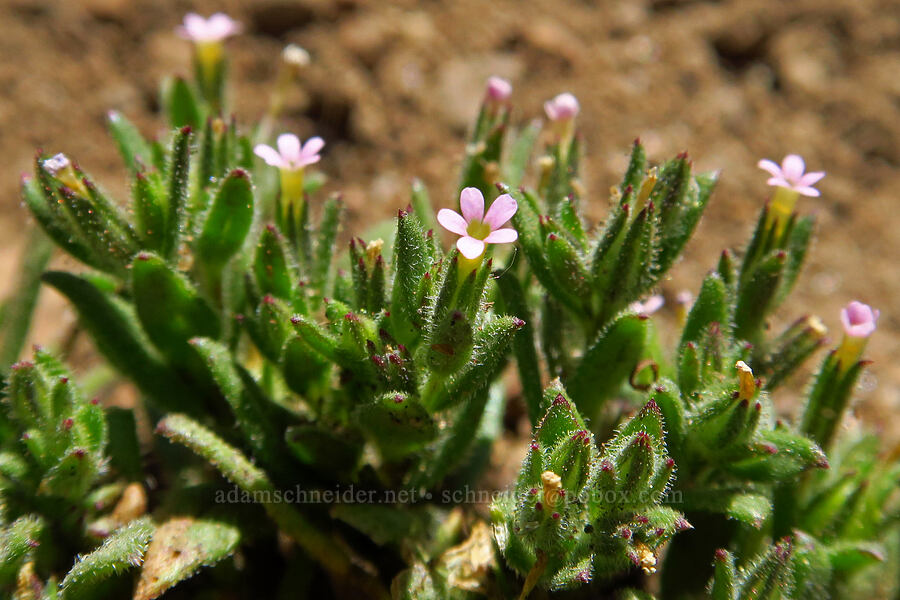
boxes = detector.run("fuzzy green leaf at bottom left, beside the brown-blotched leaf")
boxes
[60,517,154,600]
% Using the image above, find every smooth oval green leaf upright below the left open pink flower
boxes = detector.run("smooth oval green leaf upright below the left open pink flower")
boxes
[197,169,253,265]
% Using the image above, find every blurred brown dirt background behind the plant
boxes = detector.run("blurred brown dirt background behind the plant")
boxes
[0,0,900,439]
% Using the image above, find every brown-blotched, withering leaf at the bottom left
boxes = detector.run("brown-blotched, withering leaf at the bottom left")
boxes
[134,517,241,600]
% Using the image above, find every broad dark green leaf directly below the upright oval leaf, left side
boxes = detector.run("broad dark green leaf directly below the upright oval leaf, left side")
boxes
[131,253,220,362]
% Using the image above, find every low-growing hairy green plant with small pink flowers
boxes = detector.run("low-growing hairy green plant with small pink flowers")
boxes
[0,9,900,600]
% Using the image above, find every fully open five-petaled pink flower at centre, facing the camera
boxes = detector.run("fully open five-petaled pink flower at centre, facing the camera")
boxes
[438,187,519,260]
